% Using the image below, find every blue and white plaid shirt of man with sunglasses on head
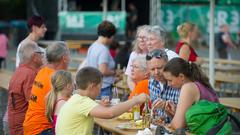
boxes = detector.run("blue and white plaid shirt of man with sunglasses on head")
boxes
[148,78,180,122]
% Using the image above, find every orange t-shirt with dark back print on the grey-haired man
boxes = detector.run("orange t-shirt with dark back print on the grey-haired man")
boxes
[23,67,54,135]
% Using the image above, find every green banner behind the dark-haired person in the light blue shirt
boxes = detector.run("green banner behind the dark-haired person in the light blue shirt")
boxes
[58,12,126,35]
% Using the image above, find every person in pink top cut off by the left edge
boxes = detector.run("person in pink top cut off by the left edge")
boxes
[0,31,8,69]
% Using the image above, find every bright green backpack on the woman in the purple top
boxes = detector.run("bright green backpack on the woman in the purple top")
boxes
[185,100,232,135]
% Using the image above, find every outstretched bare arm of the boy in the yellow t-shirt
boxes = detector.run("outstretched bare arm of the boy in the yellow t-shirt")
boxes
[90,94,149,119]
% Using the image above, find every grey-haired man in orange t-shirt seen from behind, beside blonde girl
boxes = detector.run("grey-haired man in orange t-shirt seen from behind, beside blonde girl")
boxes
[23,42,70,135]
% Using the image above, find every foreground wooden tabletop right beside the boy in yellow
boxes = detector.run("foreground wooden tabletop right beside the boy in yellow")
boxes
[94,118,155,135]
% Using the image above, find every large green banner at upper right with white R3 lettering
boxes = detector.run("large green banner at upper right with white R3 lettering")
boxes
[160,4,240,38]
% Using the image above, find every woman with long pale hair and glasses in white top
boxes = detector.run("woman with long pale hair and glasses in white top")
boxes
[125,25,150,90]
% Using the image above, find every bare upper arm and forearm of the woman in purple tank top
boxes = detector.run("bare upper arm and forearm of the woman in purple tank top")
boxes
[171,83,200,129]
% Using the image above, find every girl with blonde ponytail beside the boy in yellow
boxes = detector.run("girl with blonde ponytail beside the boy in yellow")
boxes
[46,70,73,133]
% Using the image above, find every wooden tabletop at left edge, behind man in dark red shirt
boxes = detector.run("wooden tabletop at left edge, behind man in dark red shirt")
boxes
[0,70,13,90]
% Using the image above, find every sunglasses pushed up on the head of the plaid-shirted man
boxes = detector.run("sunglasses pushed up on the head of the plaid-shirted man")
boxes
[146,49,168,61]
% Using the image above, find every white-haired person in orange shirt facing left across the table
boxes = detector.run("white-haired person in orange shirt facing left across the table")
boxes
[128,56,149,99]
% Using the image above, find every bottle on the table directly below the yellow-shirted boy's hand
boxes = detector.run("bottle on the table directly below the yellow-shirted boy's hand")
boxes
[143,101,151,128]
